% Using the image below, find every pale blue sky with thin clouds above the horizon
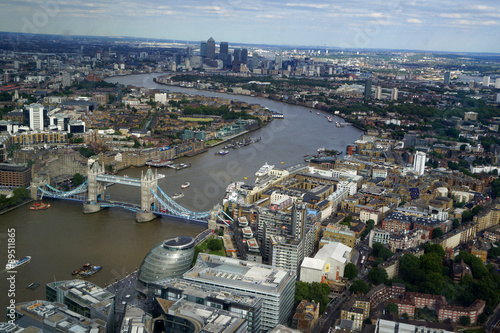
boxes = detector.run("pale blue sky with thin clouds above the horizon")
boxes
[0,0,500,53]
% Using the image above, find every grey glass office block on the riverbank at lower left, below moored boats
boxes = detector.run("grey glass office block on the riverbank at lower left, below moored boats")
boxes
[45,280,115,333]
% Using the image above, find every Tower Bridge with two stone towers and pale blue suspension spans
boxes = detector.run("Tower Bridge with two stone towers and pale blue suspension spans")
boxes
[30,162,211,223]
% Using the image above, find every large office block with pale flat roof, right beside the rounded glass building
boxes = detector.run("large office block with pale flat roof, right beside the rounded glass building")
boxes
[183,253,296,331]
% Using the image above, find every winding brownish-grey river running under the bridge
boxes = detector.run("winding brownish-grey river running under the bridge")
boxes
[0,74,362,321]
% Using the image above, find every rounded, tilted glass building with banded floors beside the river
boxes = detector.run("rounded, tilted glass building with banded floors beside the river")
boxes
[138,236,195,284]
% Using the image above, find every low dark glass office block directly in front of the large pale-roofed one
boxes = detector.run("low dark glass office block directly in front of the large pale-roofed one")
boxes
[155,279,262,333]
